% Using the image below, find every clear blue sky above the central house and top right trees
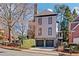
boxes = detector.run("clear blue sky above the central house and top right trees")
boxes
[38,3,79,11]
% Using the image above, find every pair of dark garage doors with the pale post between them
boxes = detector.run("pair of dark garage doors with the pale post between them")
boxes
[36,40,54,47]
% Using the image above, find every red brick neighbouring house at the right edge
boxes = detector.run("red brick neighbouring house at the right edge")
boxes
[69,16,79,44]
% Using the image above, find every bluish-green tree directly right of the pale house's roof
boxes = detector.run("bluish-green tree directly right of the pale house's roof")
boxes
[54,4,66,31]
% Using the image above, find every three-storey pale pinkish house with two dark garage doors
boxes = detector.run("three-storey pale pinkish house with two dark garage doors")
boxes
[35,10,57,47]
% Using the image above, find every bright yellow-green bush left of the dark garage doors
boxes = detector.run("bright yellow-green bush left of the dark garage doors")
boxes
[21,39,35,48]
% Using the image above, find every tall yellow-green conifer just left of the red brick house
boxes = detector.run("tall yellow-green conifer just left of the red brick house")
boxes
[61,6,73,42]
